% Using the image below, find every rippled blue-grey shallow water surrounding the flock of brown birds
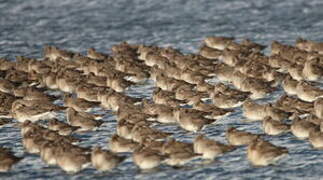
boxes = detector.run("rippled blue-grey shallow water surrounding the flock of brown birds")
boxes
[0,0,323,180]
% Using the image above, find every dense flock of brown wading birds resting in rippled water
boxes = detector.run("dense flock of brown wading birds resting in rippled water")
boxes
[0,37,323,173]
